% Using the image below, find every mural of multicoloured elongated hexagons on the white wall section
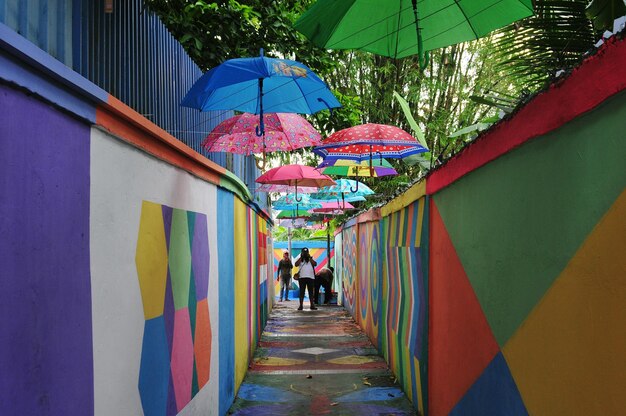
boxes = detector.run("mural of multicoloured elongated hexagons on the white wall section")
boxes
[135,201,211,416]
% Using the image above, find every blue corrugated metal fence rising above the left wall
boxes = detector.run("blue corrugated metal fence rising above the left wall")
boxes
[0,0,265,207]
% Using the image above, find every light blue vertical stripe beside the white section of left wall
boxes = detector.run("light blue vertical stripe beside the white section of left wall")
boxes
[217,189,235,415]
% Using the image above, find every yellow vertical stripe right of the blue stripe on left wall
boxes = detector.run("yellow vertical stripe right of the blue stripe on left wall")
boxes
[233,198,250,391]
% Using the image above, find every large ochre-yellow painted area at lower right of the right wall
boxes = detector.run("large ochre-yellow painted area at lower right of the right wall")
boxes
[503,191,626,415]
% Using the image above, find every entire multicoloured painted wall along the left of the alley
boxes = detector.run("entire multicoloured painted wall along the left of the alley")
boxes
[0,26,273,415]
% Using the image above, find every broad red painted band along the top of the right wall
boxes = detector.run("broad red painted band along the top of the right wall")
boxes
[426,37,626,195]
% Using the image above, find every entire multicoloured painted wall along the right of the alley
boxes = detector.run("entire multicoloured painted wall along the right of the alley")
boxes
[336,38,626,416]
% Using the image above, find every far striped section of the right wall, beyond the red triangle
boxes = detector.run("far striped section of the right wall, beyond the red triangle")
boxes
[338,186,428,413]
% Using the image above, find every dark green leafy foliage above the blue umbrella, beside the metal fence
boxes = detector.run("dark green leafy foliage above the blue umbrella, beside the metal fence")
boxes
[145,0,333,70]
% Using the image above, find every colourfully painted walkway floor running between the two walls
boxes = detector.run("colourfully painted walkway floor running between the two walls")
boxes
[228,301,416,416]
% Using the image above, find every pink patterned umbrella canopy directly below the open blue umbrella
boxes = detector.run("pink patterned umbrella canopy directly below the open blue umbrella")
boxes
[202,113,322,155]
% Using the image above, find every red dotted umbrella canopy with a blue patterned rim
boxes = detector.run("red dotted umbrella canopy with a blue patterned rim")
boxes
[313,123,428,164]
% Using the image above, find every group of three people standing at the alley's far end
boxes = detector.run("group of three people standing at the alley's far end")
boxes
[276,247,335,311]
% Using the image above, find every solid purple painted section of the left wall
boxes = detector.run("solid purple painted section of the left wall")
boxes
[0,84,93,415]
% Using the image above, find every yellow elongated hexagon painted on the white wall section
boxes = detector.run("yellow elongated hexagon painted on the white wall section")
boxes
[135,201,167,319]
